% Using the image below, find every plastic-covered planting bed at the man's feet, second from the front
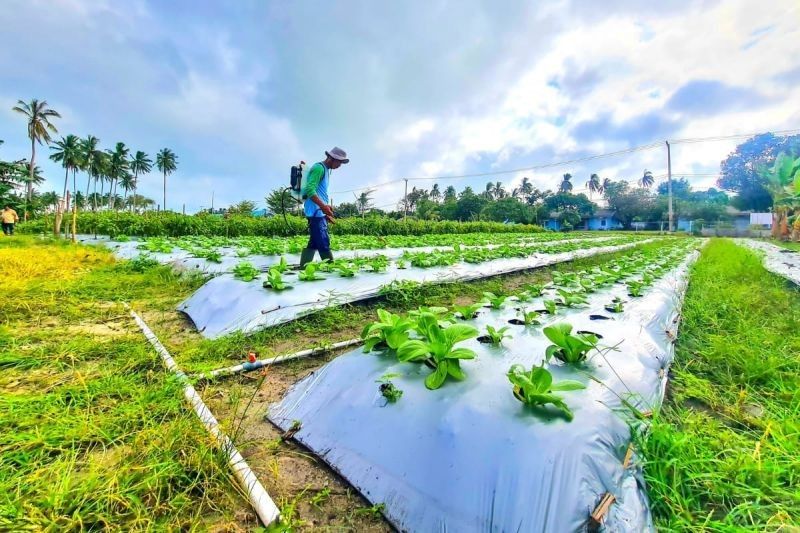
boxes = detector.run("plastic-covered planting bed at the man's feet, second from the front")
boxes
[178,236,652,338]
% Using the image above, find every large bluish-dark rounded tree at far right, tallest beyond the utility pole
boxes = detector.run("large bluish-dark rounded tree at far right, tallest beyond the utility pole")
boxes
[717,133,800,211]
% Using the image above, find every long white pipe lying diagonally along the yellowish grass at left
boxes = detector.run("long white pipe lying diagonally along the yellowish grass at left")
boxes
[125,303,280,526]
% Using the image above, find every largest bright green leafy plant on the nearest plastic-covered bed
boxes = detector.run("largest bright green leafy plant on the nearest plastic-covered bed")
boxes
[397,322,478,390]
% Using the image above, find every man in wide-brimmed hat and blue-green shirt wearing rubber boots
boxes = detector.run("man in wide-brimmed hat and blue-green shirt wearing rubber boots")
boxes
[300,147,350,268]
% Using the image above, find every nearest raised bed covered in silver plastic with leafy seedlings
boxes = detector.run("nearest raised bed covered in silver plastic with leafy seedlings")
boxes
[268,241,696,532]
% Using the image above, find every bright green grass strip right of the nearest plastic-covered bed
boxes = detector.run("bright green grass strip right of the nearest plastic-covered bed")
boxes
[640,239,800,531]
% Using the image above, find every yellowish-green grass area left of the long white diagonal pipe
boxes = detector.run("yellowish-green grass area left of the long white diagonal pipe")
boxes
[0,236,250,531]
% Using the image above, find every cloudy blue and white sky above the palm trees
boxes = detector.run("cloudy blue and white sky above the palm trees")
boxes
[0,0,800,212]
